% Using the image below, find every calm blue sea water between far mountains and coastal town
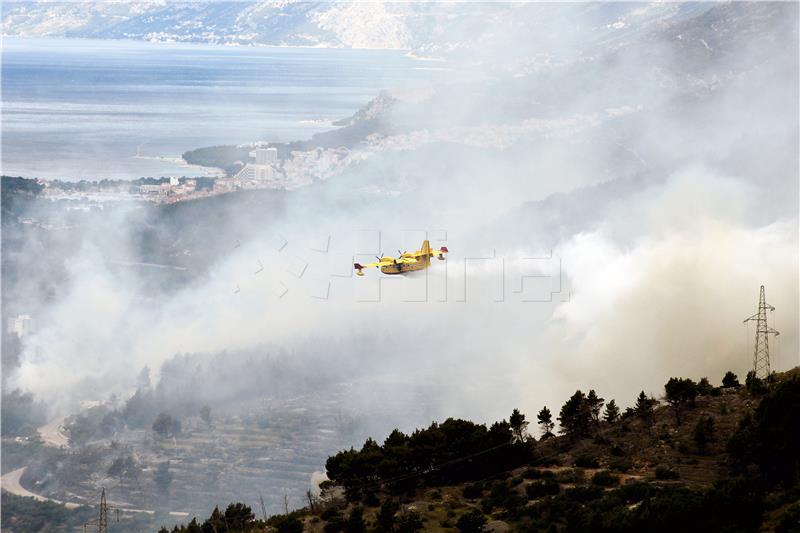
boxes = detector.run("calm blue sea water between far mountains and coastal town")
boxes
[2,37,437,180]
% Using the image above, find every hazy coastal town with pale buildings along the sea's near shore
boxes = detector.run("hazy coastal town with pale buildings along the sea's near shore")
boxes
[14,91,404,206]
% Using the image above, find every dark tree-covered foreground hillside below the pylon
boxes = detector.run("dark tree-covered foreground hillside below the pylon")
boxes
[161,368,800,533]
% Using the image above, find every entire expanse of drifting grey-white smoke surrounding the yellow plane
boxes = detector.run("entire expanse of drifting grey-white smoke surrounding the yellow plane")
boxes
[0,3,800,516]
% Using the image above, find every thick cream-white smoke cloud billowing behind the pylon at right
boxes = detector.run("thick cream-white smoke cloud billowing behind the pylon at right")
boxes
[549,168,799,410]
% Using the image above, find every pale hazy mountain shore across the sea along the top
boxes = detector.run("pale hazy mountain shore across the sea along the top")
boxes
[2,0,709,53]
